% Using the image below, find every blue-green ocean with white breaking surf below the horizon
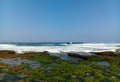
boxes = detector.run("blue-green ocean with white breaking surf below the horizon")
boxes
[0,42,120,53]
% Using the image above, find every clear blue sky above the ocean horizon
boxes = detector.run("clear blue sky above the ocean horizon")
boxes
[0,0,120,42]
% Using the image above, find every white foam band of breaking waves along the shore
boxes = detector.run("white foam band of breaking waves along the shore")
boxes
[0,43,120,53]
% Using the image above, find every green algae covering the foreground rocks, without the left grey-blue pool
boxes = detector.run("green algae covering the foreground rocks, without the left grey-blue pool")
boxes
[0,52,120,82]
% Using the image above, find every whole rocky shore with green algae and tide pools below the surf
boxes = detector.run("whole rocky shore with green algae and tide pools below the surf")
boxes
[0,50,120,82]
